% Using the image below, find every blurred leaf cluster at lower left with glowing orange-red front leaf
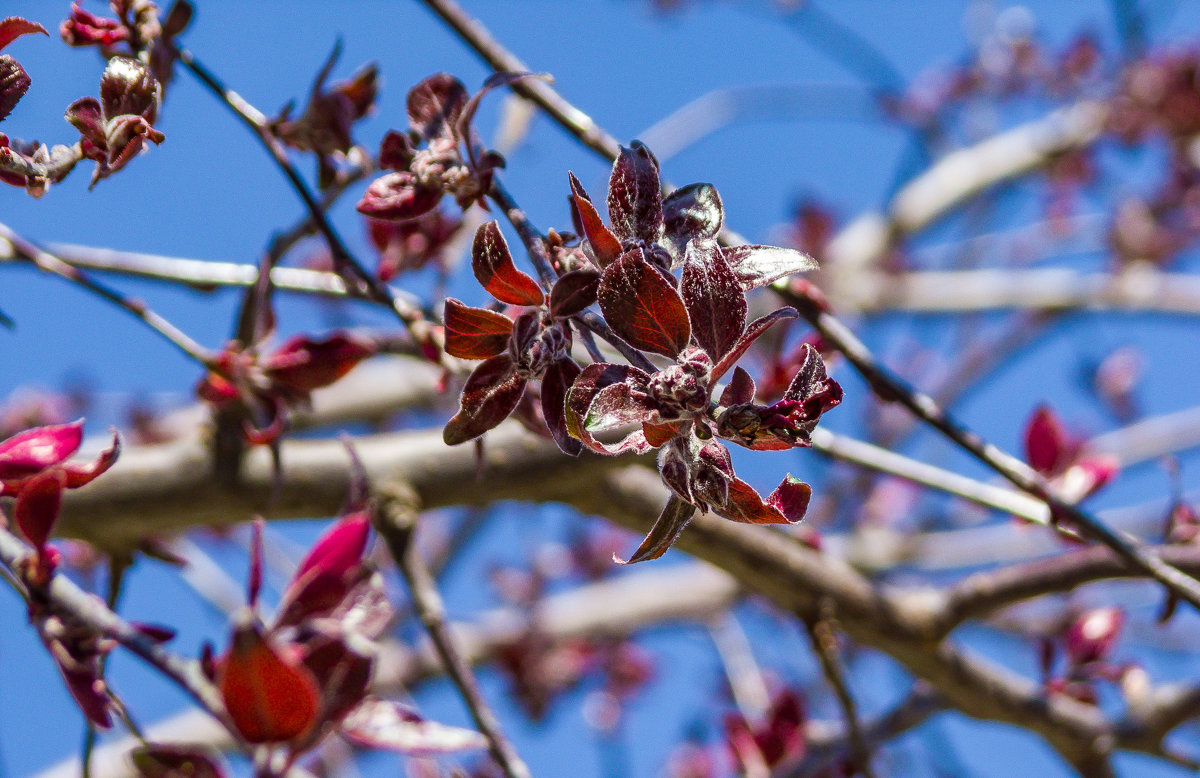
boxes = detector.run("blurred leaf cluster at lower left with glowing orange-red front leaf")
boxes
[175,511,485,774]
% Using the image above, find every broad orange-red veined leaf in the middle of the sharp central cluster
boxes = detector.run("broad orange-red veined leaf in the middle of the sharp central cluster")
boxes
[599,249,691,357]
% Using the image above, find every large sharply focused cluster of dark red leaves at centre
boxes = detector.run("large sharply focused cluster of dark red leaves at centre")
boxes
[444,136,841,562]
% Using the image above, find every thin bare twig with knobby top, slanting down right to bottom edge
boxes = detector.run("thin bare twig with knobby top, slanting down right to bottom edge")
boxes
[372,493,530,778]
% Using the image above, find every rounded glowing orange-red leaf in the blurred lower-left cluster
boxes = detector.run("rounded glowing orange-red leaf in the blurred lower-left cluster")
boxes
[217,622,319,743]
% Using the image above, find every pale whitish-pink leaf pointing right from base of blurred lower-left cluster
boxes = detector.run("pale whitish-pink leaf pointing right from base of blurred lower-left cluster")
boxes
[342,698,487,756]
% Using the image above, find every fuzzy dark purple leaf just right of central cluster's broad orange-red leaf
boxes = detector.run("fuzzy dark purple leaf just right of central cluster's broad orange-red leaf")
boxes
[680,238,748,363]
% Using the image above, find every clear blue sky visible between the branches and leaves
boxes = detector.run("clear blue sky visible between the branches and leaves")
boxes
[0,0,1200,778]
